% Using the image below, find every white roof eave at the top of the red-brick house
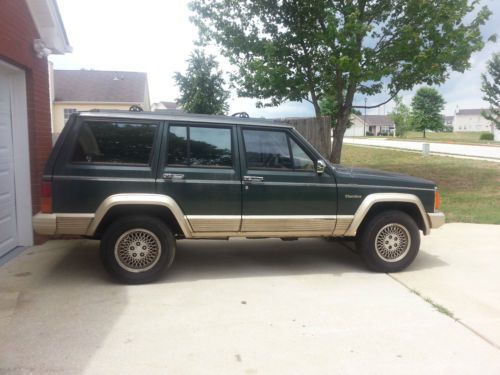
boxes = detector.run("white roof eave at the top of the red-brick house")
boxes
[26,0,72,56]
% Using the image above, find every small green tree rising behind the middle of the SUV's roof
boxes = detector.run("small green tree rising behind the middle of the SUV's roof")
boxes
[174,50,229,115]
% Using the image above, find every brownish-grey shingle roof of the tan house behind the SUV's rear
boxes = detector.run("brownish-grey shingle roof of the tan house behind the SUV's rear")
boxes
[54,70,148,104]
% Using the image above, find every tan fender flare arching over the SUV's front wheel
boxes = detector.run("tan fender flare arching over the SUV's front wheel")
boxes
[344,193,431,237]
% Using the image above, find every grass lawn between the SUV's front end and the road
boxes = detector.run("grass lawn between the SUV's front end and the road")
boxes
[342,144,500,224]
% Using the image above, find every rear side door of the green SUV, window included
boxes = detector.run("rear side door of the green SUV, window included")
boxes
[157,122,241,233]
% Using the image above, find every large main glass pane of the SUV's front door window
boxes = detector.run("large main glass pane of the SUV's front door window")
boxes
[243,129,293,169]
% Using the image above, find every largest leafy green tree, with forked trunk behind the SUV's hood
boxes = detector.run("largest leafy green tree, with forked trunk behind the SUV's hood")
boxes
[190,0,491,162]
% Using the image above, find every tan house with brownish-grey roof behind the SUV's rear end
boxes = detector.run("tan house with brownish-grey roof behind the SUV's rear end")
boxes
[52,70,150,136]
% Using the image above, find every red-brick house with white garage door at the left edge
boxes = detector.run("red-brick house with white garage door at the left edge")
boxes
[0,0,71,259]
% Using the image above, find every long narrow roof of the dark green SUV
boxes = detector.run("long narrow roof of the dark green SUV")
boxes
[78,109,293,128]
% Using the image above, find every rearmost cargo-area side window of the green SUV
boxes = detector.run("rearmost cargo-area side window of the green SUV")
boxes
[71,121,158,165]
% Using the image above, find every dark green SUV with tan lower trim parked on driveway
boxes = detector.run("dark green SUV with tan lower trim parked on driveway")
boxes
[33,111,444,283]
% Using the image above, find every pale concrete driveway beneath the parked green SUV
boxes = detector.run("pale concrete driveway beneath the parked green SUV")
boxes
[0,224,500,374]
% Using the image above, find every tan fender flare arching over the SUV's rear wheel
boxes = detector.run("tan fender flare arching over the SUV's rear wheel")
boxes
[87,193,193,238]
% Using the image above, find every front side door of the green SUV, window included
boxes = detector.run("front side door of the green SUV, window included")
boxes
[241,127,337,236]
